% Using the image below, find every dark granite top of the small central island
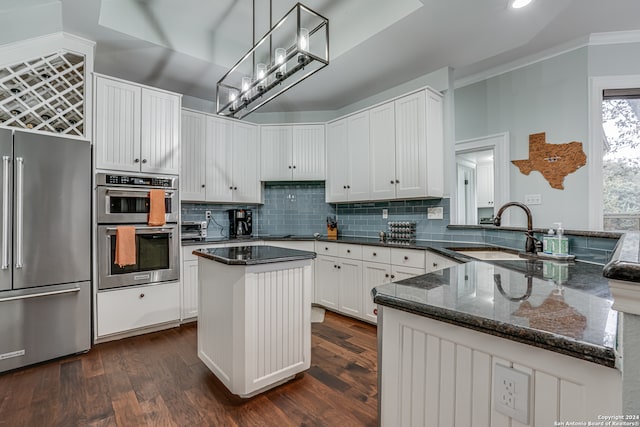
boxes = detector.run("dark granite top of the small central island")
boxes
[193,245,316,265]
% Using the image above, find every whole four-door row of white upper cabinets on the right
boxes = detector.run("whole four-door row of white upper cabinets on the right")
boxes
[326,89,444,202]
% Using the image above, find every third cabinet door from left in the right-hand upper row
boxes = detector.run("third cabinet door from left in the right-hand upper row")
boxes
[369,102,396,200]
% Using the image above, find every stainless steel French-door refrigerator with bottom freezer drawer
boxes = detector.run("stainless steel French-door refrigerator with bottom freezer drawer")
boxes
[0,129,91,372]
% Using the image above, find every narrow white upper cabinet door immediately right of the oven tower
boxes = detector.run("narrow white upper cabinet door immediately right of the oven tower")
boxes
[180,110,207,201]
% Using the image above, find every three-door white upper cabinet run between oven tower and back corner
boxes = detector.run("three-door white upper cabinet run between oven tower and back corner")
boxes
[180,110,262,203]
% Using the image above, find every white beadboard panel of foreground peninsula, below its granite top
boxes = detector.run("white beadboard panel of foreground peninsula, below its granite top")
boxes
[378,306,622,427]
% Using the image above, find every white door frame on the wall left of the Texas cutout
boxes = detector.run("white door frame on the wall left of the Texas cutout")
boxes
[450,132,510,225]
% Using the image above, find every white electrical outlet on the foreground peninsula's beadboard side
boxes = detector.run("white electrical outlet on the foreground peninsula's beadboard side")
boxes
[493,364,530,424]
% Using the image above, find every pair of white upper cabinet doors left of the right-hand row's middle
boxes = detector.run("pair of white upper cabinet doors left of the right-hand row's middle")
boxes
[325,111,370,203]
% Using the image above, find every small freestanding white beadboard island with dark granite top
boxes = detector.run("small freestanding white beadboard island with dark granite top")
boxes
[193,246,316,398]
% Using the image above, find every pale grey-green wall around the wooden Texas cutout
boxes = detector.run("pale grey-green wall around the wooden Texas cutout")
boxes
[456,47,589,229]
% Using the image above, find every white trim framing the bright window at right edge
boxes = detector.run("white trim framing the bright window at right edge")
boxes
[587,75,640,230]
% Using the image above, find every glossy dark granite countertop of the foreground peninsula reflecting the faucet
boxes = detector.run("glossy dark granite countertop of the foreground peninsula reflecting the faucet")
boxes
[372,260,617,367]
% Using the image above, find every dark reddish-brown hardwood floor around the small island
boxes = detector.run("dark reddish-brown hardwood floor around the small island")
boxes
[0,312,378,427]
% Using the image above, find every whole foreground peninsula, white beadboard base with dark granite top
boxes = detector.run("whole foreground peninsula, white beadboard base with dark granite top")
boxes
[372,260,622,426]
